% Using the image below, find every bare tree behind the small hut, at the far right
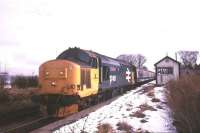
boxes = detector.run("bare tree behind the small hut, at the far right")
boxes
[178,51,199,67]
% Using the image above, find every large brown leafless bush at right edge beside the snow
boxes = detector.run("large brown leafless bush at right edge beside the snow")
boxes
[166,75,200,133]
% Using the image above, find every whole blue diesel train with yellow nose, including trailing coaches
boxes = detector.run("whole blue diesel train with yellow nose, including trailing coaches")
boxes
[32,47,155,117]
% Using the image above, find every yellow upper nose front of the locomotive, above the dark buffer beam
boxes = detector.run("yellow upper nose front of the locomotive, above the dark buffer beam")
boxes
[39,60,80,95]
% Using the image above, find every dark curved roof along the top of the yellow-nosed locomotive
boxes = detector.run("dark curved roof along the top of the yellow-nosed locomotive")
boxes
[56,47,130,66]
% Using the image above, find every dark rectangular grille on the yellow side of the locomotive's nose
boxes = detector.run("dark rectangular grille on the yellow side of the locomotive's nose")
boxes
[81,69,91,88]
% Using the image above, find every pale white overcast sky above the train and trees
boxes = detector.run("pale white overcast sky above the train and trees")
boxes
[0,0,200,74]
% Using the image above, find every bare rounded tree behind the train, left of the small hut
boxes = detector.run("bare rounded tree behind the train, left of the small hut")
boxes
[117,54,146,68]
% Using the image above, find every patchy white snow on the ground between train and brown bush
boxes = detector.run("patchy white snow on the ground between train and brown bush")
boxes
[54,82,176,133]
